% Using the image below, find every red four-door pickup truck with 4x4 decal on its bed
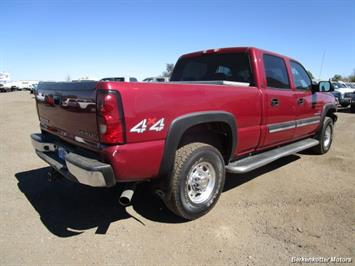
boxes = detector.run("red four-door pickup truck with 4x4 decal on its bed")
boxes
[31,47,337,219]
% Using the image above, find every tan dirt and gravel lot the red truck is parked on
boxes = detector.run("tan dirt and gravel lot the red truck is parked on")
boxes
[0,92,355,265]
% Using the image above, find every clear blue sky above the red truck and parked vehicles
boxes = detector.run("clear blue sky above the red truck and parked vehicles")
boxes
[0,0,355,80]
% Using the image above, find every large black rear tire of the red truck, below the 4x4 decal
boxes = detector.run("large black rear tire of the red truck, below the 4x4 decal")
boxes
[164,142,225,220]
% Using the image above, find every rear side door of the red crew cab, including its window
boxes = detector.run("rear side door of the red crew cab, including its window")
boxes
[260,54,296,148]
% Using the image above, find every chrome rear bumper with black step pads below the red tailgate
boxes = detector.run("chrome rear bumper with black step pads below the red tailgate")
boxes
[31,134,116,187]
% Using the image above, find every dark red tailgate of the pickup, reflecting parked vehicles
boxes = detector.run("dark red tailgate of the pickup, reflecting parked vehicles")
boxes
[36,81,99,146]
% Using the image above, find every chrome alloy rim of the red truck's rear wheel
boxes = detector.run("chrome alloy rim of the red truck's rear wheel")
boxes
[186,162,216,204]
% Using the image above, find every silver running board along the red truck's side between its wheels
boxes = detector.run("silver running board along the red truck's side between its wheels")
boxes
[226,138,319,174]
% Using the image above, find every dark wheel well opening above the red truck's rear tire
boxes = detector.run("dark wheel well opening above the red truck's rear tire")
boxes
[178,122,233,164]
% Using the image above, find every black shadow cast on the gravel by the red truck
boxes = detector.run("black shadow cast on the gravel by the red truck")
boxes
[15,155,299,237]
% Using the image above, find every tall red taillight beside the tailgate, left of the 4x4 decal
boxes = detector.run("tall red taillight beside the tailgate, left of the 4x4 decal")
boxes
[97,90,125,144]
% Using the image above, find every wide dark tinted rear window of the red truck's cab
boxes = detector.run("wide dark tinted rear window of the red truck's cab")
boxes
[170,53,253,83]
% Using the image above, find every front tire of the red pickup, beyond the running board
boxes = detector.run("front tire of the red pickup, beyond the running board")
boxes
[312,116,334,154]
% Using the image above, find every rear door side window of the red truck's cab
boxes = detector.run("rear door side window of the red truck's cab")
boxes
[263,54,290,89]
